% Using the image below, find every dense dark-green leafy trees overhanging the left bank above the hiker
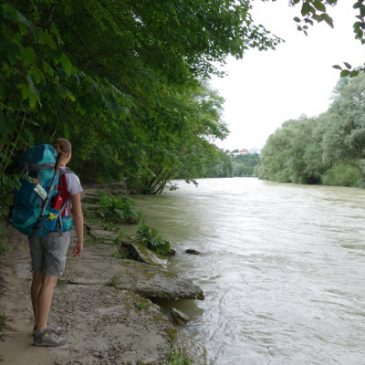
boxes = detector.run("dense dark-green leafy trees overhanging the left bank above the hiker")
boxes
[0,0,279,198]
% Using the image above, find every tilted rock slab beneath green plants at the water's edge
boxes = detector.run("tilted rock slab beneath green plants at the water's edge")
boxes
[120,241,167,268]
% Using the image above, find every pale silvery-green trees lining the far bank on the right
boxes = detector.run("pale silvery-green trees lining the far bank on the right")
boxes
[258,74,365,187]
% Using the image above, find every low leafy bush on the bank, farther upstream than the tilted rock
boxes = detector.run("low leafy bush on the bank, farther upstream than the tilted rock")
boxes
[96,193,142,224]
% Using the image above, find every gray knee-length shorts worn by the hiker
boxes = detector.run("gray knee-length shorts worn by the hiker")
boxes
[29,231,70,276]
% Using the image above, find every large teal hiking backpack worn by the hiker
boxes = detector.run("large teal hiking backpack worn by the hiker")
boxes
[10,144,73,237]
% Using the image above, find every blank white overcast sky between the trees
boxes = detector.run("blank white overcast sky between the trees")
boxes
[210,0,365,150]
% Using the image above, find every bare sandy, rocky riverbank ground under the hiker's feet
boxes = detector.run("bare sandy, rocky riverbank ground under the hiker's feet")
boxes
[0,185,203,365]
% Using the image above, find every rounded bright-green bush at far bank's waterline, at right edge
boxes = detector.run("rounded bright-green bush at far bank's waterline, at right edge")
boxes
[322,162,362,186]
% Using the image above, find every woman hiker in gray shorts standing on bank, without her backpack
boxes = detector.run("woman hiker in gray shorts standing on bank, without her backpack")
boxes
[29,138,84,346]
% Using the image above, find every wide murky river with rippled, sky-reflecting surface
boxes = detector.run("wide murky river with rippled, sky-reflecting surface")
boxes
[133,178,365,365]
